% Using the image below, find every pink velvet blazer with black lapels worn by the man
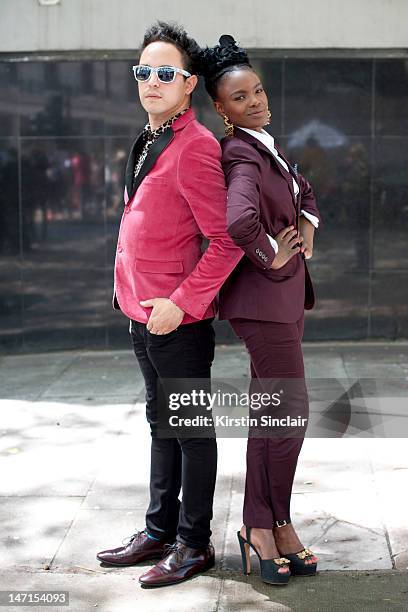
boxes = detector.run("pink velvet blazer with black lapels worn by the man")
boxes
[113,109,243,323]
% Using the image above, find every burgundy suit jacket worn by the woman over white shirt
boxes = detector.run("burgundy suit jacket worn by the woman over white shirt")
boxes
[219,128,321,323]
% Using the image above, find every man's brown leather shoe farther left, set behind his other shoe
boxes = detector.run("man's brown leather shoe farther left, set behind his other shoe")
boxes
[96,530,175,567]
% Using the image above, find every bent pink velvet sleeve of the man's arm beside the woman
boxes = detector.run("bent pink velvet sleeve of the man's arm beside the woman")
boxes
[170,136,243,319]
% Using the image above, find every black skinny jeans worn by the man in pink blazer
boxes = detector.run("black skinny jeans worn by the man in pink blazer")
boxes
[131,319,217,548]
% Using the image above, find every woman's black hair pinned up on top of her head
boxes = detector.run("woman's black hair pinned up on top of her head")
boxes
[198,34,252,100]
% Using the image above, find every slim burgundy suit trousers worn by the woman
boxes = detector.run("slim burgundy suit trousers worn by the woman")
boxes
[230,314,309,529]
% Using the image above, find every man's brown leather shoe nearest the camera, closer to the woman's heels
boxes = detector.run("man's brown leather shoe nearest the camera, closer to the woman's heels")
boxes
[139,542,215,587]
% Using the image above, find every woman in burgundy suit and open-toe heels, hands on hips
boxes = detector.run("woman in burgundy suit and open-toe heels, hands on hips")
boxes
[202,35,320,584]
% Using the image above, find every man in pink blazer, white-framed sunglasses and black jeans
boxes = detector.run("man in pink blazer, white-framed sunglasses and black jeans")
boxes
[97,22,243,587]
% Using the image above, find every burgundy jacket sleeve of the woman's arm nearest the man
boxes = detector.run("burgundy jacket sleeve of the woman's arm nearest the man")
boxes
[223,139,275,270]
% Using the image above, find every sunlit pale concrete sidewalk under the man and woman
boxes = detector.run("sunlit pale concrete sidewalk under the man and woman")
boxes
[0,342,408,612]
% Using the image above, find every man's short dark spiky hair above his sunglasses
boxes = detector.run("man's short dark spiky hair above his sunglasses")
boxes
[141,21,200,74]
